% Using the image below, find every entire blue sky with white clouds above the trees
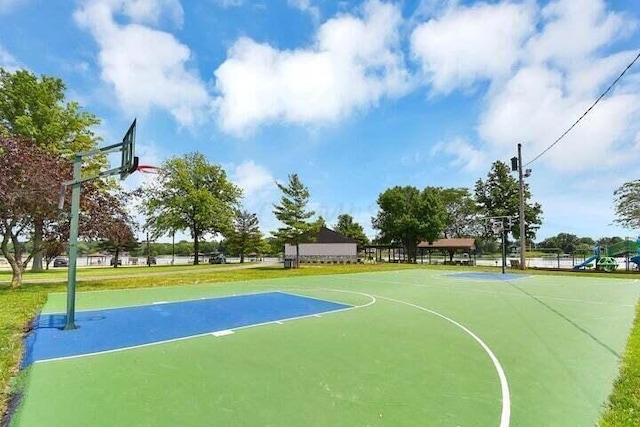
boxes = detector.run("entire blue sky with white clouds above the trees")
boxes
[0,0,640,244]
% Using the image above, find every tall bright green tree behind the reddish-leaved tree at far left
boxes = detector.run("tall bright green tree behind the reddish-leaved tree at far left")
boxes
[0,68,101,271]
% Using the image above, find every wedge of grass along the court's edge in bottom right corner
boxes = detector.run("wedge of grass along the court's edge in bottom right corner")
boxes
[599,302,640,427]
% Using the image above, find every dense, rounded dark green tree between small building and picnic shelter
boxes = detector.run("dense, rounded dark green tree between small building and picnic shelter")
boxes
[372,186,446,262]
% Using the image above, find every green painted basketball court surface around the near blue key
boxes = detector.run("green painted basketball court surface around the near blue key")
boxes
[11,269,640,427]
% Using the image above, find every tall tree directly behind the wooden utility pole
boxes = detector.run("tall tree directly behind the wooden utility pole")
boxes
[475,161,542,240]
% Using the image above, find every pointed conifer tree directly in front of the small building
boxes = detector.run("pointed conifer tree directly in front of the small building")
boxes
[273,174,318,266]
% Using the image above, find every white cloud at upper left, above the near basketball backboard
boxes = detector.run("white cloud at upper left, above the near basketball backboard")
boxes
[75,0,210,126]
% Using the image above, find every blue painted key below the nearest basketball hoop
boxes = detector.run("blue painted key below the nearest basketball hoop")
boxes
[23,292,351,367]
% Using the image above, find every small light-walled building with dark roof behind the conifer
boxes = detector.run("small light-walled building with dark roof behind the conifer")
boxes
[284,227,358,263]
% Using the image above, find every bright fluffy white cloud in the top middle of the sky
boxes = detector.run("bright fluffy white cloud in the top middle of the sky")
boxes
[215,0,408,135]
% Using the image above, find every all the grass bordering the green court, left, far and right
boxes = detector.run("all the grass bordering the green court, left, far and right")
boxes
[0,264,640,426]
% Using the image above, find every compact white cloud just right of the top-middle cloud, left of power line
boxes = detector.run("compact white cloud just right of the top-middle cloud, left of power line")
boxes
[411,2,535,93]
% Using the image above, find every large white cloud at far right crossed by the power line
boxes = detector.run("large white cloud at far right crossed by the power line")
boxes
[478,0,640,174]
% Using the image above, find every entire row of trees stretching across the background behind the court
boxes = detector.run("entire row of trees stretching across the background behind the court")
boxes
[0,68,640,286]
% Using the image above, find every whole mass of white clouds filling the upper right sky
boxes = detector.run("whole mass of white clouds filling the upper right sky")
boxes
[411,0,640,173]
